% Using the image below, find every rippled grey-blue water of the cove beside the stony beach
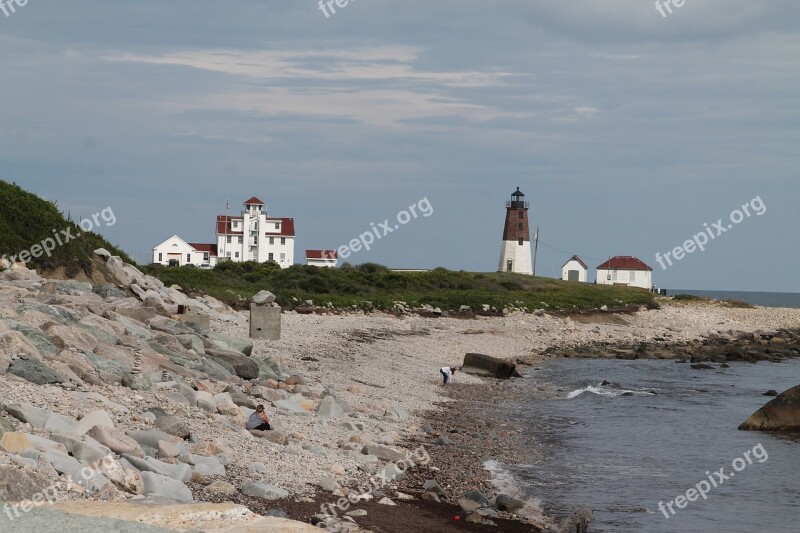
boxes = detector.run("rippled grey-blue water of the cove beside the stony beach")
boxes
[492,359,800,533]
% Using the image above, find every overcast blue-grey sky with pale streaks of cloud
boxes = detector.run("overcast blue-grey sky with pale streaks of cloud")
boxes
[0,0,800,292]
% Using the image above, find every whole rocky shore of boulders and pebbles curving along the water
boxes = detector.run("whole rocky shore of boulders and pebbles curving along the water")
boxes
[0,255,800,533]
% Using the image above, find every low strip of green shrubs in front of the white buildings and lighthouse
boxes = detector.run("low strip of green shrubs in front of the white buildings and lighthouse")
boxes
[145,262,653,312]
